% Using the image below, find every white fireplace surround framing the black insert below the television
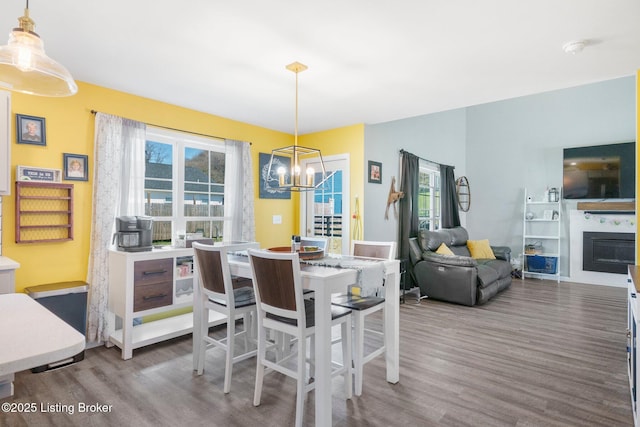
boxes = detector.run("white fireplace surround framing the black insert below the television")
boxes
[569,210,636,287]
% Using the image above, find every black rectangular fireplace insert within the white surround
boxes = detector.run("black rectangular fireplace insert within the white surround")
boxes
[582,231,635,274]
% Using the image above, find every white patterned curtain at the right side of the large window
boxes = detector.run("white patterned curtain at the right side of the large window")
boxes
[223,139,256,242]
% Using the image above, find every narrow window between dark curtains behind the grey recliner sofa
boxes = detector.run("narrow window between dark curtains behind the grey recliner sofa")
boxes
[418,160,440,230]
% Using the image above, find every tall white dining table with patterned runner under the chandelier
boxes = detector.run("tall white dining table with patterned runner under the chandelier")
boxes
[218,252,400,426]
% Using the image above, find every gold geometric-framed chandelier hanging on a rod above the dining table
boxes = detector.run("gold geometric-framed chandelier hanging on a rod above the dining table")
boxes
[267,62,327,191]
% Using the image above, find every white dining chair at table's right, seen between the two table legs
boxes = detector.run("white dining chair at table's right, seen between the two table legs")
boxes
[331,240,396,396]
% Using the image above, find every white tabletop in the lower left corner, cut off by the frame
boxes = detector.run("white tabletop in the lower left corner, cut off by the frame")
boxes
[0,293,85,398]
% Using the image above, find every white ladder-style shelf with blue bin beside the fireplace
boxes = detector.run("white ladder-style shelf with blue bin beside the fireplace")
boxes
[522,188,562,282]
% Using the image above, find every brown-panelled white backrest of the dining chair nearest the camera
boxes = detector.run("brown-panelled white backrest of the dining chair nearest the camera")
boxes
[247,249,306,327]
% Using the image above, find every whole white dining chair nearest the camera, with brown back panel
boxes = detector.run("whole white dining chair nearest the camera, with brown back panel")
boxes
[248,249,352,426]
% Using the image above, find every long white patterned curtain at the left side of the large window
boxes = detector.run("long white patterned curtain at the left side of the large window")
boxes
[87,113,146,342]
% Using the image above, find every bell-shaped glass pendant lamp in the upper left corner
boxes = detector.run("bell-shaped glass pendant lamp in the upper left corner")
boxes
[0,0,78,96]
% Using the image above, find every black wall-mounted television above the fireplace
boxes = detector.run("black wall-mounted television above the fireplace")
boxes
[562,142,636,200]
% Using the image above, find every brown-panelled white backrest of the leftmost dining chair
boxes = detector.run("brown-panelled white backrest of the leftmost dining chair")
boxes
[192,242,251,307]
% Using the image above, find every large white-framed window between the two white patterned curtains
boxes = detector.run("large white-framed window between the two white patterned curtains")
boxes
[144,128,225,245]
